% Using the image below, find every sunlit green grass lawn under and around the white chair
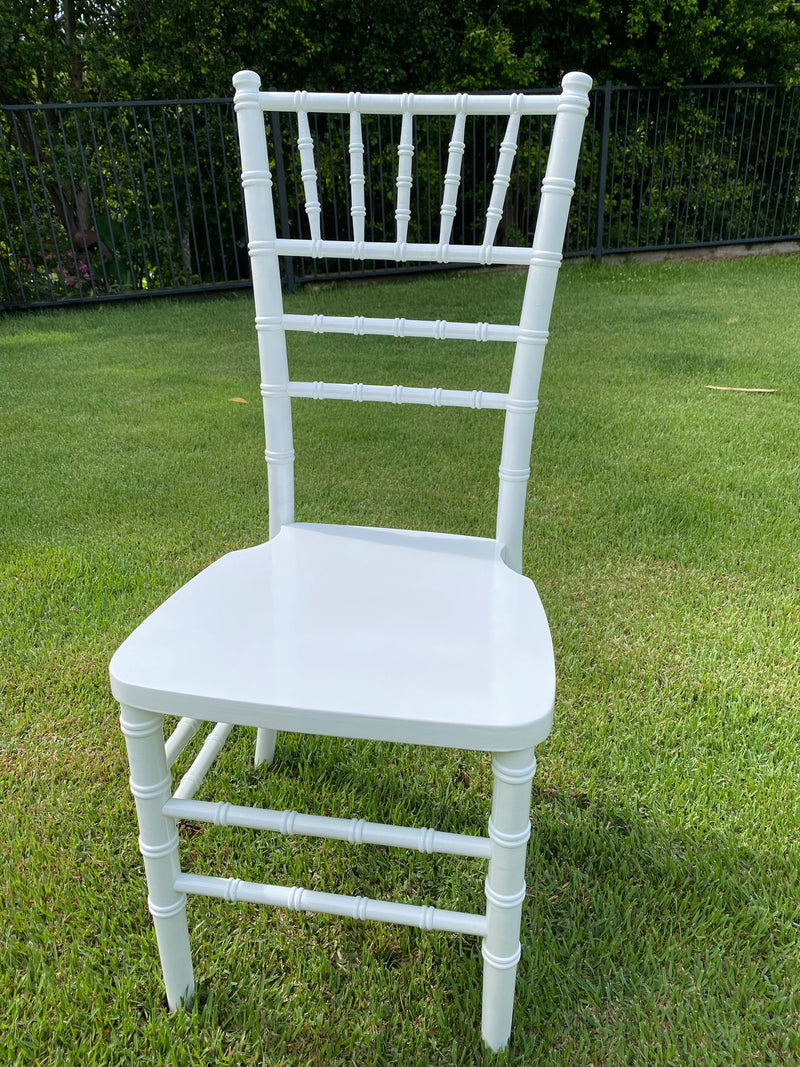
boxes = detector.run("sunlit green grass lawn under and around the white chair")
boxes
[0,257,800,1067]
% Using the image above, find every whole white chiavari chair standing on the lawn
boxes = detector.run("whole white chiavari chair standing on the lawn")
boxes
[111,70,591,1050]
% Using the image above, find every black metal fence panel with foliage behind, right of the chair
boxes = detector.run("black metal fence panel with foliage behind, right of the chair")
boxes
[597,86,800,251]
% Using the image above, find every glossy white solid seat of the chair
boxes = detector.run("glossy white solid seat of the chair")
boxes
[110,523,555,751]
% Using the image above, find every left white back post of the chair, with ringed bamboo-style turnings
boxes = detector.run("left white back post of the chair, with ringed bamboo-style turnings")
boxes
[234,70,294,538]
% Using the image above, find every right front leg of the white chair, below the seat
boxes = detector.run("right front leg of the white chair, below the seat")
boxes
[481,748,537,1052]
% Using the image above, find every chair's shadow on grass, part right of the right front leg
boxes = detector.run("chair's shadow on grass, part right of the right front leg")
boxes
[513,791,798,1064]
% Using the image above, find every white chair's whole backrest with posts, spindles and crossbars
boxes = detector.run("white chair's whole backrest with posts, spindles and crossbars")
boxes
[234,70,592,571]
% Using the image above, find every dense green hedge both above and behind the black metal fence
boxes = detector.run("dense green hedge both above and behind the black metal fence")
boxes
[0,0,800,303]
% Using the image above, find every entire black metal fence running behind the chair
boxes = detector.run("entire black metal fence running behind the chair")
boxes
[0,84,800,309]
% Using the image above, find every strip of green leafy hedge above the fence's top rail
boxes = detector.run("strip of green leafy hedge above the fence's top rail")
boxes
[0,0,800,103]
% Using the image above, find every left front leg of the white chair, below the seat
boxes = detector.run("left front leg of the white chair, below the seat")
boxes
[119,707,194,1010]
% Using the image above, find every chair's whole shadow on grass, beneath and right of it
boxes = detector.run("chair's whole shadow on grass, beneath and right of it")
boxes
[164,735,791,1064]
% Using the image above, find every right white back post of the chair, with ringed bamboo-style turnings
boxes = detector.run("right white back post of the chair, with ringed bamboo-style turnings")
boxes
[496,73,592,572]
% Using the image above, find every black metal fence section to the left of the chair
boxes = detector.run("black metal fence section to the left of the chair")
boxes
[0,100,247,307]
